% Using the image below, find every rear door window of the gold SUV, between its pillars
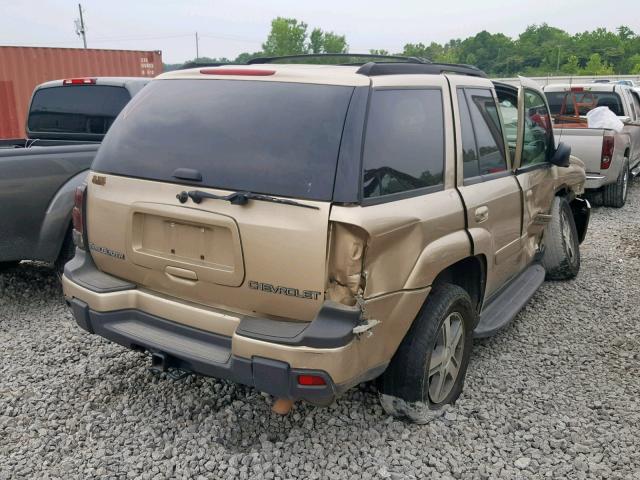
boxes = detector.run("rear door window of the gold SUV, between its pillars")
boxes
[465,88,507,175]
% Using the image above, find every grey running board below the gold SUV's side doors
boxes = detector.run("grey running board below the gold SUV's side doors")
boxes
[473,263,545,338]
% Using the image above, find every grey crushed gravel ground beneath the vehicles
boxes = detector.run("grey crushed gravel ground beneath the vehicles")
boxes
[0,181,640,479]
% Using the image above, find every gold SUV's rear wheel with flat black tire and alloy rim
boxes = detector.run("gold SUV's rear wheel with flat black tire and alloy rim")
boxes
[380,283,476,423]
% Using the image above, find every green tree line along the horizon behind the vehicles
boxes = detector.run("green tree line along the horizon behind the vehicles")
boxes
[165,17,640,77]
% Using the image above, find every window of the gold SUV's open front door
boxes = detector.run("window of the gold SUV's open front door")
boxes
[521,90,554,167]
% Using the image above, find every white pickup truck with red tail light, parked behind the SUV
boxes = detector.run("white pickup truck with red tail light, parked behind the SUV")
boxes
[544,83,640,207]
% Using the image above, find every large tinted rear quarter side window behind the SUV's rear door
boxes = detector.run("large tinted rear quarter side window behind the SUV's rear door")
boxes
[363,90,444,198]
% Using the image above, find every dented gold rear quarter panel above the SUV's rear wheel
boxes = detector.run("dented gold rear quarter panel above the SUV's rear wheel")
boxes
[330,189,471,299]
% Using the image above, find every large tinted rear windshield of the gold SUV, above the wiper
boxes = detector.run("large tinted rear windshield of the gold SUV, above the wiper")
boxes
[93,79,353,201]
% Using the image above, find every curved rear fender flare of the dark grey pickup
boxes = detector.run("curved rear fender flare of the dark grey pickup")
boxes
[34,170,88,262]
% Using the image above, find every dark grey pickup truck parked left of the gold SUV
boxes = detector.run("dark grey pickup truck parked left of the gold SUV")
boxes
[0,77,150,271]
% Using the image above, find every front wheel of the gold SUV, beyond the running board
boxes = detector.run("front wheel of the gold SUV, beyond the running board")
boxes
[542,197,580,280]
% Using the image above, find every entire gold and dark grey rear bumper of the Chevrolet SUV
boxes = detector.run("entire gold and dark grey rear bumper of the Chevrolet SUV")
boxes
[62,250,386,404]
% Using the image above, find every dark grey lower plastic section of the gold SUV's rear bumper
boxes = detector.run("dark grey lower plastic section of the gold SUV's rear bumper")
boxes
[69,298,343,404]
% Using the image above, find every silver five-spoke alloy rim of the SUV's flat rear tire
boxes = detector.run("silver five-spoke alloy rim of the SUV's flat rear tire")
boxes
[428,312,464,403]
